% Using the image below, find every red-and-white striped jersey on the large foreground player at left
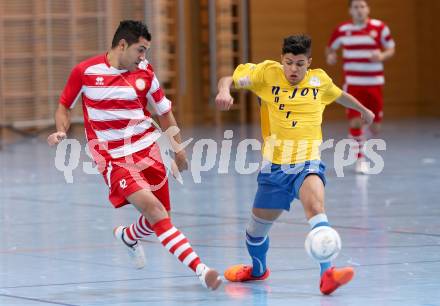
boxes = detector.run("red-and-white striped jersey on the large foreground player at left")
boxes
[60,54,171,163]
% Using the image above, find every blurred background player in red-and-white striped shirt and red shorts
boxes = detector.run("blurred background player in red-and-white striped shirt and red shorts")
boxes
[326,0,395,173]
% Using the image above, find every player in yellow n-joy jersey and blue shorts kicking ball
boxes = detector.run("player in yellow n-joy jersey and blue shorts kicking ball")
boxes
[216,35,374,294]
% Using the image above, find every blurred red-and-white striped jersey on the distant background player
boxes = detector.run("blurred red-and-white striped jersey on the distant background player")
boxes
[328,19,395,86]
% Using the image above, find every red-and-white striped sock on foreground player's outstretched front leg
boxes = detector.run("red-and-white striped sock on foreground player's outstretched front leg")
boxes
[152,218,201,272]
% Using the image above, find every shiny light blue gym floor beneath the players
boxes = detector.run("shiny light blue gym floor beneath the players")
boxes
[0,120,440,306]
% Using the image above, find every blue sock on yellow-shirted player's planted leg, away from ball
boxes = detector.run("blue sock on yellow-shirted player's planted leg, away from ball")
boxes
[246,232,269,277]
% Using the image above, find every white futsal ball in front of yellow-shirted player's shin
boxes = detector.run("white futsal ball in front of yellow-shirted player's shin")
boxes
[305,226,341,262]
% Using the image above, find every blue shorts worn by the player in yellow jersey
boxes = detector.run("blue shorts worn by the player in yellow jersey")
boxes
[254,160,326,210]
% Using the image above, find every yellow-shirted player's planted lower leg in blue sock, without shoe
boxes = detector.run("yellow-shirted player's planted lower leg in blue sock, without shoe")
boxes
[246,207,283,277]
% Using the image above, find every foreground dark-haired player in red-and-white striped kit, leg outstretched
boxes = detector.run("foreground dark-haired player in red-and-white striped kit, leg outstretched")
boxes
[48,20,221,289]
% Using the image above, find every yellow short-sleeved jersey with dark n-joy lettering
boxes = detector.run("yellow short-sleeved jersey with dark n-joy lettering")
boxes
[233,61,342,164]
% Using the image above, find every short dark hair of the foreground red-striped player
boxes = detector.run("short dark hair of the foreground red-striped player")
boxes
[112,20,151,48]
